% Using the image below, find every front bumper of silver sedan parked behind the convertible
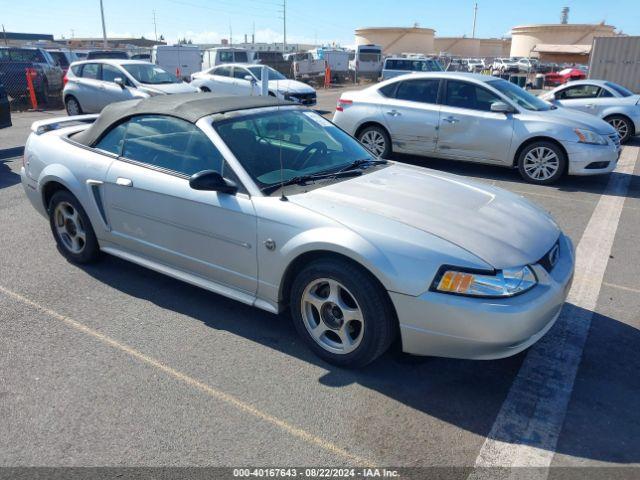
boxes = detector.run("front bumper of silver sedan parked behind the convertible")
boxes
[562,142,622,175]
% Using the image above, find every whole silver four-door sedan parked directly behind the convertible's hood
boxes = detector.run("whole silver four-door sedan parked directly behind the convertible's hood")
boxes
[333,72,621,184]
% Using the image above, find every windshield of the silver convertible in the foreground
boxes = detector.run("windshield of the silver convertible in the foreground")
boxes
[213,108,375,191]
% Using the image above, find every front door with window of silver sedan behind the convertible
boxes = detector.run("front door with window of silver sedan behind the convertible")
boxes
[437,80,513,164]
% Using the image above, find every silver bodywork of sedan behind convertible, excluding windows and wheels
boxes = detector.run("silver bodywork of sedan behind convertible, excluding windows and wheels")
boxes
[333,72,620,175]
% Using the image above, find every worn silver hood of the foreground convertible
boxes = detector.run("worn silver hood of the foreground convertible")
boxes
[289,163,560,269]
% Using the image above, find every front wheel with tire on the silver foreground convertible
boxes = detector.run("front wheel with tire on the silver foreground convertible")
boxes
[291,258,396,367]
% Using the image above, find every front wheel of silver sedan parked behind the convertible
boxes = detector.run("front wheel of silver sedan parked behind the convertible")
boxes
[518,141,567,185]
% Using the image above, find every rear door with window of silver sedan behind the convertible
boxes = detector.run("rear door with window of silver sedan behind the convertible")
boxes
[380,78,440,155]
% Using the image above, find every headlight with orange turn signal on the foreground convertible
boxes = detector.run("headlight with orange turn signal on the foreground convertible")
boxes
[431,266,538,298]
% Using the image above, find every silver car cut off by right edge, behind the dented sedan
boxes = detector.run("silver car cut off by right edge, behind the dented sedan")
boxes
[540,80,640,143]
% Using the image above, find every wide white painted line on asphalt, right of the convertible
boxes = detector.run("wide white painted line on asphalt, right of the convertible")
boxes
[469,147,638,479]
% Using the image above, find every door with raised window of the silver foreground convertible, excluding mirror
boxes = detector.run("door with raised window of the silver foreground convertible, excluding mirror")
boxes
[98,115,257,295]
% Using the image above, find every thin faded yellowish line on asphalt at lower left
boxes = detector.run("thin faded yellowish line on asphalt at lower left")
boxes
[0,285,374,466]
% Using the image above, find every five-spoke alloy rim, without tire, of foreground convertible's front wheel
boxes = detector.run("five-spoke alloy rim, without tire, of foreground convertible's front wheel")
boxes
[300,278,365,355]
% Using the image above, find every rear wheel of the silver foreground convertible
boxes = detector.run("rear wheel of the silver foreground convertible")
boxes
[49,190,100,263]
